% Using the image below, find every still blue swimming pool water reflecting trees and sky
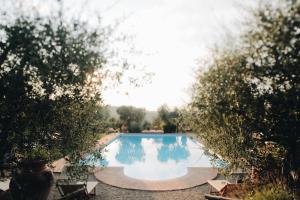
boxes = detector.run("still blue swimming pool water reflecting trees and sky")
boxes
[85,134,211,180]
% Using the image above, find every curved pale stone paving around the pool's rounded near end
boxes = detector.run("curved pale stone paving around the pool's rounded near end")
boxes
[95,167,218,191]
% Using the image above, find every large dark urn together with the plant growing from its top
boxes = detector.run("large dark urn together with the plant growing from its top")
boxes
[9,147,54,200]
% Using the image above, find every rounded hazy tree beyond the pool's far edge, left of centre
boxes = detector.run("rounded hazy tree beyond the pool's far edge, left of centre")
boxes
[117,106,145,133]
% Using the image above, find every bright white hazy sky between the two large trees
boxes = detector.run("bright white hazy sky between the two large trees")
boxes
[2,0,254,110]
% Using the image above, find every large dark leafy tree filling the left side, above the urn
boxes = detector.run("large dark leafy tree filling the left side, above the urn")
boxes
[0,16,110,175]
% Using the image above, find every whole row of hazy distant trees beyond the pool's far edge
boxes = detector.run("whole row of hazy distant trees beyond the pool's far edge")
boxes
[101,105,186,133]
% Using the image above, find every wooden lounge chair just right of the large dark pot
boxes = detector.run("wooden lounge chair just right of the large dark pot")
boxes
[56,180,98,200]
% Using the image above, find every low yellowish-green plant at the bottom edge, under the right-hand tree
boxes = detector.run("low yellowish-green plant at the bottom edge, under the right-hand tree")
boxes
[246,185,294,200]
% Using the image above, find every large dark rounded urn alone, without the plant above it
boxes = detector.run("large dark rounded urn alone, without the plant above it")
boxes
[9,160,54,200]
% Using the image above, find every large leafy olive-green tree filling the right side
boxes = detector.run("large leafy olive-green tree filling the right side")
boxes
[189,1,300,186]
